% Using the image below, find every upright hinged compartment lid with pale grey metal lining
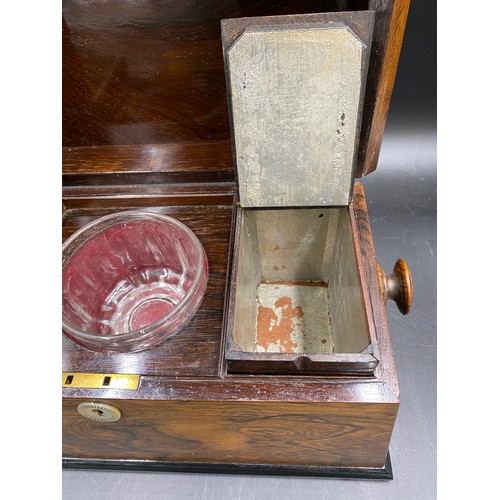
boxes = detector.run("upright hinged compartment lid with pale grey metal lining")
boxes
[223,11,373,207]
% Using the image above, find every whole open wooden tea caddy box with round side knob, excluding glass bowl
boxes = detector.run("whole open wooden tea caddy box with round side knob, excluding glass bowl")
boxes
[62,0,412,479]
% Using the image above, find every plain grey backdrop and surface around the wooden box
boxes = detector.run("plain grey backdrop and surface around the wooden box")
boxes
[62,1,436,500]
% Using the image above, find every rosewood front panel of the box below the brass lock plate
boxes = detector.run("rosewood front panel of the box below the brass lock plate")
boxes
[63,398,398,467]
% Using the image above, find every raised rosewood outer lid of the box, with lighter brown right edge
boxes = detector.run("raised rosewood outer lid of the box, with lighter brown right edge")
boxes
[62,0,409,178]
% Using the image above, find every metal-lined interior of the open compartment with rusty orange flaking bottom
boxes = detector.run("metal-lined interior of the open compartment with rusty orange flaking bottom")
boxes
[233,208,370,354]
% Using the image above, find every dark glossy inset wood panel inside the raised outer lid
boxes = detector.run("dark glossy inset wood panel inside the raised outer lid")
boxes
[63,0,346,146]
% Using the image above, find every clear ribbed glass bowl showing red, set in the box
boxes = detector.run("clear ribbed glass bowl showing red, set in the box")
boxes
[62,211,208,352]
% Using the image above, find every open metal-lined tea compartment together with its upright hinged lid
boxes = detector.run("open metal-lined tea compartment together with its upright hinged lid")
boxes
[223,12,378,374]
